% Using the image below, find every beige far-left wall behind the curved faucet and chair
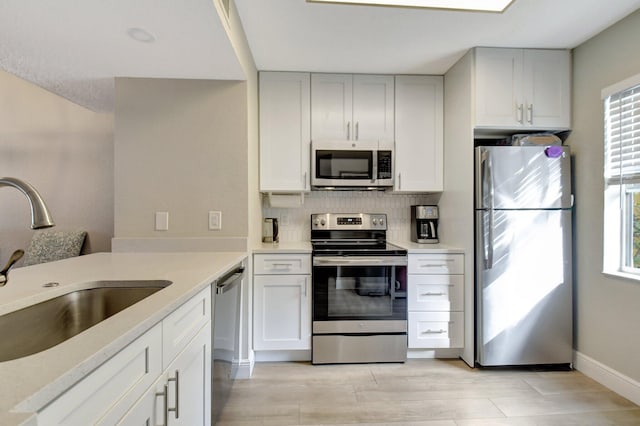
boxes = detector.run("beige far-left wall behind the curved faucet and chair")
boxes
[0,71,113,267]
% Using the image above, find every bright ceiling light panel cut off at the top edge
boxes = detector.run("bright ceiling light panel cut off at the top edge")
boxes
[307,0,514,12]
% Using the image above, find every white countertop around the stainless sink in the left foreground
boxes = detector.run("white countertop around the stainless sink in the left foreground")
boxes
[0,252,247,425]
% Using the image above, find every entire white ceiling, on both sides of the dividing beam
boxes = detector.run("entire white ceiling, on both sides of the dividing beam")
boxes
[0,0,640,111]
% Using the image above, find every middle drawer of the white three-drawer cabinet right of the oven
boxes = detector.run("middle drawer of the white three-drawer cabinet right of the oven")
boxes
[407,275,464,311]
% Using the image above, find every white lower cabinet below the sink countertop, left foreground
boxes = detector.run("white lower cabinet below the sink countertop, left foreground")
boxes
[38,287,211,426]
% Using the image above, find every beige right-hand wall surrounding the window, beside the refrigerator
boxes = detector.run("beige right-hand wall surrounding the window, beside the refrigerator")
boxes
[567,11,640,381]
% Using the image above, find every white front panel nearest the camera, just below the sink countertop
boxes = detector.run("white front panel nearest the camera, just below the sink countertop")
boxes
[38,324,162,425]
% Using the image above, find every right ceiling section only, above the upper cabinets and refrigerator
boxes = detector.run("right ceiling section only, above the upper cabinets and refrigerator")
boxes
[235,0,640,75]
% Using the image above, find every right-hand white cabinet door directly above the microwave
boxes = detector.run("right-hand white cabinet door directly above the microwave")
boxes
[351,75,394,142]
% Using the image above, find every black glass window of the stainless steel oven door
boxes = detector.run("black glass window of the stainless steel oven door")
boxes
[313,266,406,321]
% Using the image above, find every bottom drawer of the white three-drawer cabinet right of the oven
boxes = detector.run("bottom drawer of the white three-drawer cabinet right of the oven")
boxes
[408,312,464,348]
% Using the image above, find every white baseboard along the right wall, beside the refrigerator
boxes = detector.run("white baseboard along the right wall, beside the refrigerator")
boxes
[574,351,640,405]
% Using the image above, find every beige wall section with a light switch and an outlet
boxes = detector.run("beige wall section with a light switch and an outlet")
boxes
[114,78,248,238]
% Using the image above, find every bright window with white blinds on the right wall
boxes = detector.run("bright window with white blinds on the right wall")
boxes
[603,75,640,279]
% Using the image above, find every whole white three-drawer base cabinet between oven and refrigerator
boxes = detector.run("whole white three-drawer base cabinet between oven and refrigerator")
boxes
[407,253,464,349]
